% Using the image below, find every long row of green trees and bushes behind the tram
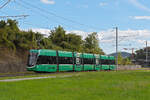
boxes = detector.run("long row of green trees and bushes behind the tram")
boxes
[0,19,104,54]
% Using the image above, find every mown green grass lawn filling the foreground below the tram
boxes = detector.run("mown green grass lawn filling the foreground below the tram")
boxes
[0,70,150,100]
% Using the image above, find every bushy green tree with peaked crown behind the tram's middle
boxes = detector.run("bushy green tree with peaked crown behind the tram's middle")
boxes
[49,26,83,51]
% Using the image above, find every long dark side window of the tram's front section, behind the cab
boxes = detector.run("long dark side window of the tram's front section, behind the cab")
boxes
[37,56,57,64]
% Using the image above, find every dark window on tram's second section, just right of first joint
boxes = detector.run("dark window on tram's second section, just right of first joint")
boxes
[58,57,73,64]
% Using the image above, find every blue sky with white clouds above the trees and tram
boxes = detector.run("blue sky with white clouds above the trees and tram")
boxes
[0,0,150,54]
